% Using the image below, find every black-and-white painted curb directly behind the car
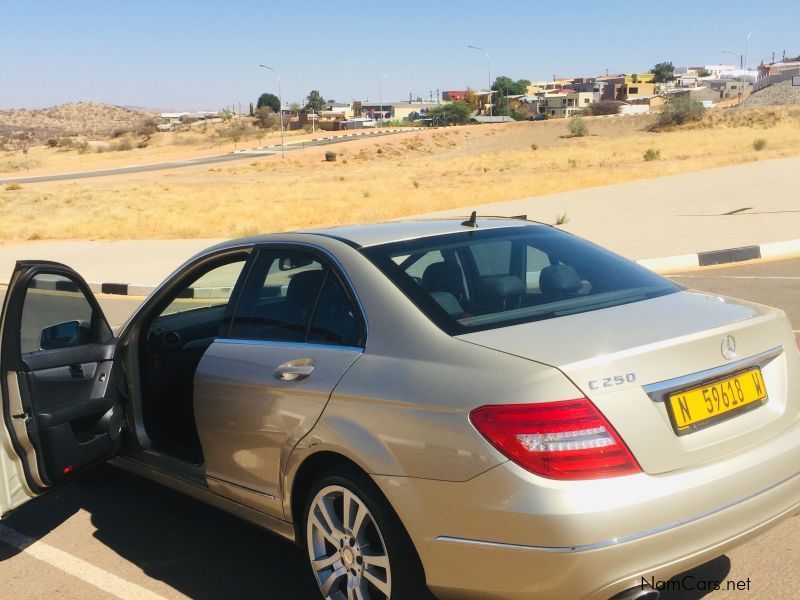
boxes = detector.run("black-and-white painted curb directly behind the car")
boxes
[72,239,800,299]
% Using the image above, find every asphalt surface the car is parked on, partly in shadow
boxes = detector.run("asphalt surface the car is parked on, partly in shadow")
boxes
[0,259,800,600]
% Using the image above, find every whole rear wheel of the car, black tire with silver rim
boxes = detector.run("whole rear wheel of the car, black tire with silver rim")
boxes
[299,467,434,600]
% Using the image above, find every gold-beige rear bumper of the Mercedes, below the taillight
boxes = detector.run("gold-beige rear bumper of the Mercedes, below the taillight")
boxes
[376,418,800,600]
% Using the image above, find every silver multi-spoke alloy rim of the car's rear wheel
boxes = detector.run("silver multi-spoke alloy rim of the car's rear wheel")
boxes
[306,485,392,600]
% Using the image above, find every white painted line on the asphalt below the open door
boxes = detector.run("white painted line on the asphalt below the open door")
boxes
[0,524,166,600]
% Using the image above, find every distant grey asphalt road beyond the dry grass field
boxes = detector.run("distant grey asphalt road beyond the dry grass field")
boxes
[0,131,418,185]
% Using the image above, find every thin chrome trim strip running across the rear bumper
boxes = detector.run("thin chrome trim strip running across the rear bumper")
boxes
[436,464,800,552]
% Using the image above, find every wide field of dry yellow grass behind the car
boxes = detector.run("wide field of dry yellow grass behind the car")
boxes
[0,110,800,240]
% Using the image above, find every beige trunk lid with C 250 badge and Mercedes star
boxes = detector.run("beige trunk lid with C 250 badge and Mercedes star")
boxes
[458,291,800,474]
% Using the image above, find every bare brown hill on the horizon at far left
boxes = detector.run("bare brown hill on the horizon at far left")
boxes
[0,102,155,144]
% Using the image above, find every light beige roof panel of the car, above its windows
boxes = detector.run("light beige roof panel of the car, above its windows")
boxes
[216,216,546,248]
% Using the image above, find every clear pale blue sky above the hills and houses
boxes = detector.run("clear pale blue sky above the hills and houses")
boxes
[0,0,800,109]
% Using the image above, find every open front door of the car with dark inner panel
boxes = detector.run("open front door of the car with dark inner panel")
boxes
[0,261,124,515]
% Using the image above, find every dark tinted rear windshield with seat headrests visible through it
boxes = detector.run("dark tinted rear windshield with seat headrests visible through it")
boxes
[362,225,682,335]
